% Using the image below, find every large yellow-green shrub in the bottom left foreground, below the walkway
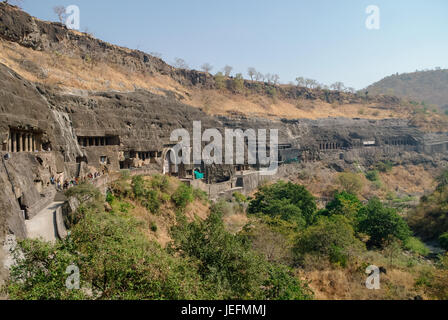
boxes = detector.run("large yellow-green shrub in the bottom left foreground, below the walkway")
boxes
[8,211,205,300]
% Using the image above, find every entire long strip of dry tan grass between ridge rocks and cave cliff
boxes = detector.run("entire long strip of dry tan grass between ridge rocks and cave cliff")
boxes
[0,40,409,119]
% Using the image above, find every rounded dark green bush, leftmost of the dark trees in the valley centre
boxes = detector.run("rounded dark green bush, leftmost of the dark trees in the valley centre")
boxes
[248,181,317,225]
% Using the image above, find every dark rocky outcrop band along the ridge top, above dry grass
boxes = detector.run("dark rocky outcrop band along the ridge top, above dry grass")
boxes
[0,3,400,107]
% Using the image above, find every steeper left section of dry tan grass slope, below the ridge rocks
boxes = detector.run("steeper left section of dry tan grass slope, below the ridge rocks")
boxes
[0,40,181,94]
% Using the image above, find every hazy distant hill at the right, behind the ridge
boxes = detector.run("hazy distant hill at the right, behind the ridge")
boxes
[367,69,448,110]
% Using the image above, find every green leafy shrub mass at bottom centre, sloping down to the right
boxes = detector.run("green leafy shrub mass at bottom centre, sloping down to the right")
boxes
[173,203,311,300]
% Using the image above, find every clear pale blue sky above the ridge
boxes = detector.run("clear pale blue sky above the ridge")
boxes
[22,0,448,89]
